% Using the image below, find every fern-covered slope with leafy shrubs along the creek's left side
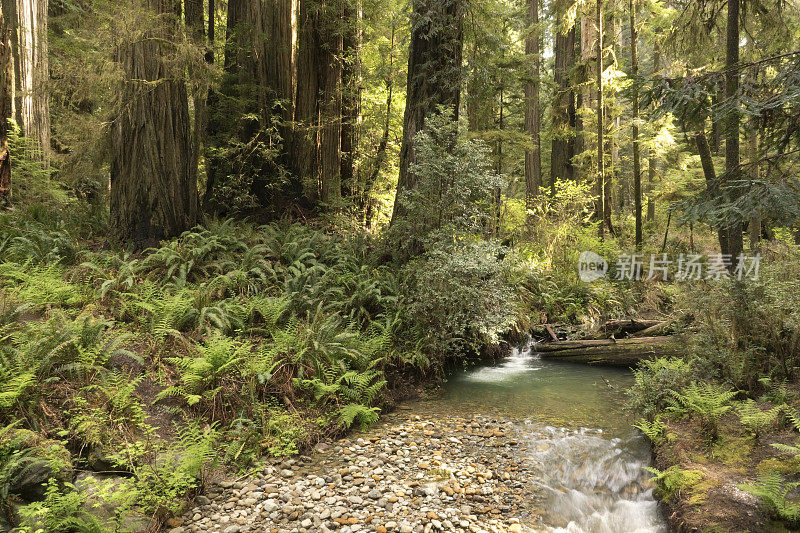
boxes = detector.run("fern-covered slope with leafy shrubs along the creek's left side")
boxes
[0,120,648,531]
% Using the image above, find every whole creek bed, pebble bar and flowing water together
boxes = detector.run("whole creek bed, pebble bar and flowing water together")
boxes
[171,342,667,533]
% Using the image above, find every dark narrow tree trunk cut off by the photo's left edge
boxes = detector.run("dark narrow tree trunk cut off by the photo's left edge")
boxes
[0,0,14,209]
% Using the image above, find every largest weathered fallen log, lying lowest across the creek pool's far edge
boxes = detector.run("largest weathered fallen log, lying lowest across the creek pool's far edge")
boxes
[534,336,686,368]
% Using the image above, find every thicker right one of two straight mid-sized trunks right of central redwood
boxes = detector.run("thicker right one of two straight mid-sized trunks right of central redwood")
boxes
[550,0,575,194]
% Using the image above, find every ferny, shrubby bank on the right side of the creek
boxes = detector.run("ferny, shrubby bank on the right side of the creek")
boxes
[630,250,800,531]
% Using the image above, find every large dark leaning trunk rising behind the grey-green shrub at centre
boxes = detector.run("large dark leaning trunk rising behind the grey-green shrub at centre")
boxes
[392,0,464,227]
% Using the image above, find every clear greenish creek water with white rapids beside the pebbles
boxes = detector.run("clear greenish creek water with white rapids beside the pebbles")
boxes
[416,346,668,533]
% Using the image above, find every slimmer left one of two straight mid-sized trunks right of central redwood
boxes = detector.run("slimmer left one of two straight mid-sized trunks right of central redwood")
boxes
[525,0,542,216]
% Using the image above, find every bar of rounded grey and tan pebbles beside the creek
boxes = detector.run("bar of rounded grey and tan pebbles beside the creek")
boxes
[176,412,539,533]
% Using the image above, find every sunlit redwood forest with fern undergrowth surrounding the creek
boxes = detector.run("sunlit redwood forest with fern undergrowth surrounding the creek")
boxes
[0,0,800,531]
